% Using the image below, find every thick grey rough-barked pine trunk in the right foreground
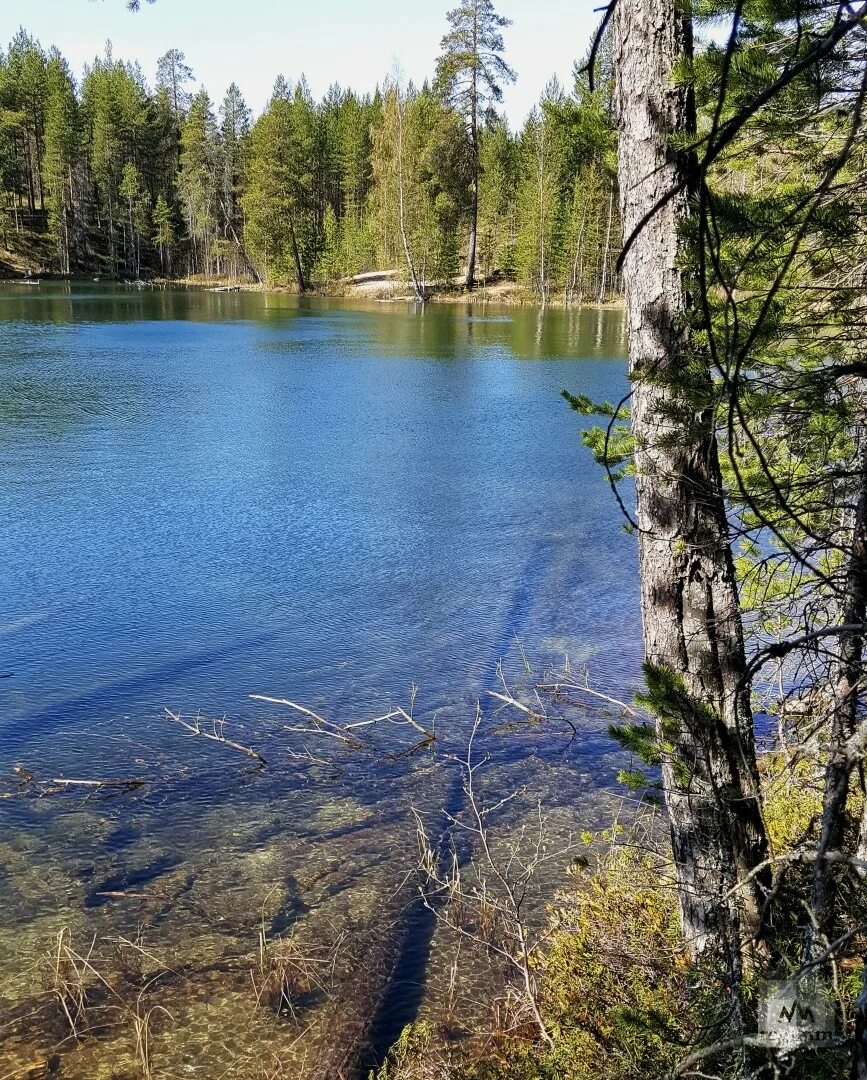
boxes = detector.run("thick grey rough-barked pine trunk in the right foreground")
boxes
[614,0,767,972]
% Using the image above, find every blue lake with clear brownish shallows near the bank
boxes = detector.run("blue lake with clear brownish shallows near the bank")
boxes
[0,284,640,1078]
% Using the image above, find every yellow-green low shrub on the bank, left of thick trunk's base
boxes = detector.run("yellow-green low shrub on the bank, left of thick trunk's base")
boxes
[470,841,695,1080]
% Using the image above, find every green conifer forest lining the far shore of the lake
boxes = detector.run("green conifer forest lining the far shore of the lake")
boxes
[0,22,620,302]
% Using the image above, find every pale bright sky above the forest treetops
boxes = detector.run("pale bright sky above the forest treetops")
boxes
[0,0,600,126]
